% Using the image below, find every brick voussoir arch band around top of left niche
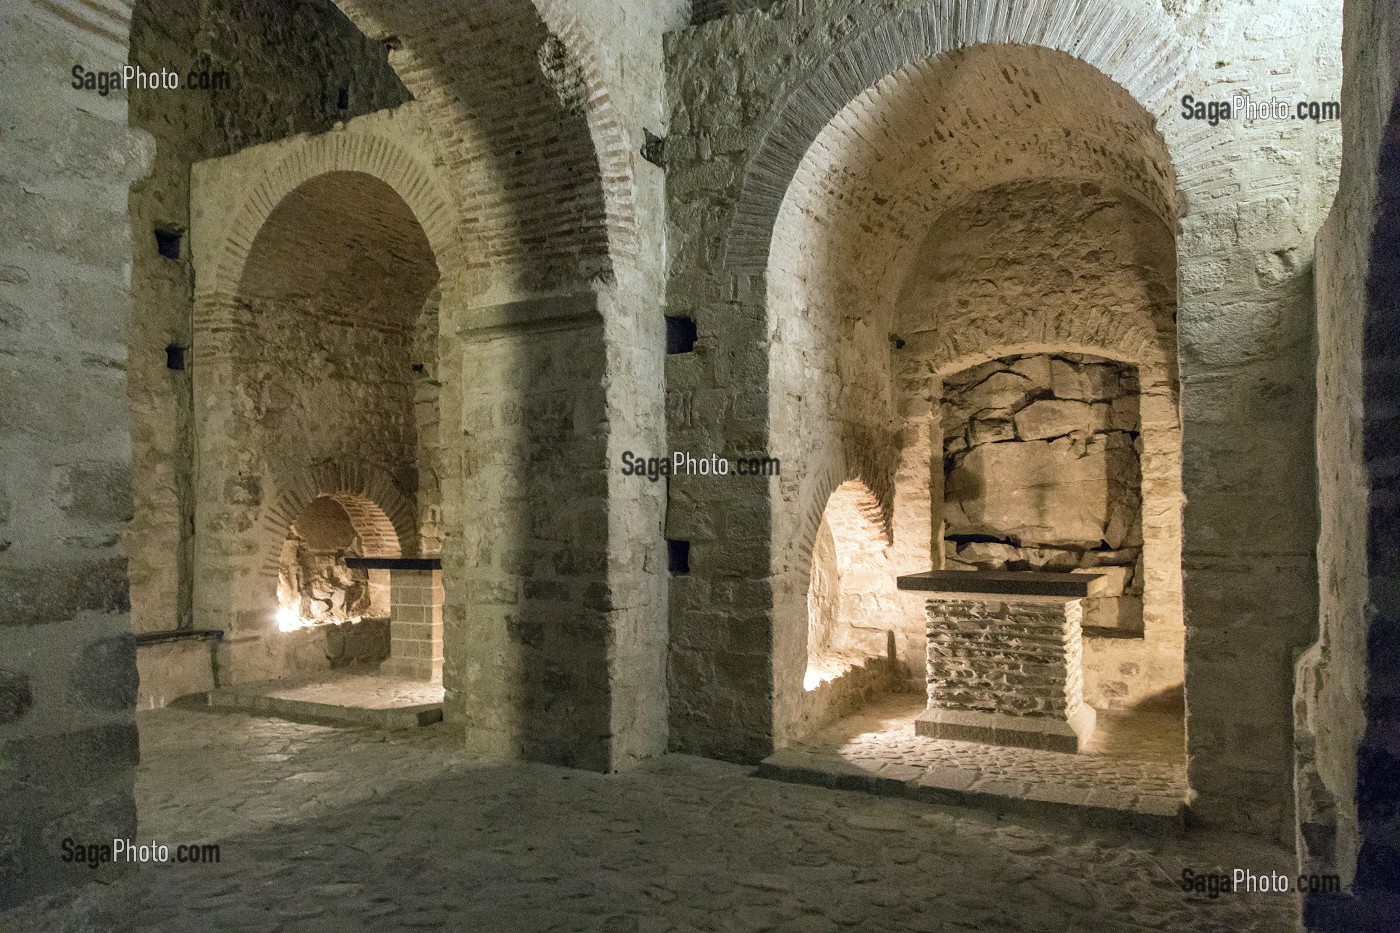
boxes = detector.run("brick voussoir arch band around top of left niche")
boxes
[195,130,456,325]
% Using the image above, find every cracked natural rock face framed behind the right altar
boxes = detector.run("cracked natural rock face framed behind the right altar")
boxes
[942,353,1144,632]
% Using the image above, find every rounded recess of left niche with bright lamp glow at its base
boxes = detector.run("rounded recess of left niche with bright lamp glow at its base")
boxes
[195,170,438,678]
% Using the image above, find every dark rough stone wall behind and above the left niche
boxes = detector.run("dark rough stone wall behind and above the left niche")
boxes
[127,0,409,705]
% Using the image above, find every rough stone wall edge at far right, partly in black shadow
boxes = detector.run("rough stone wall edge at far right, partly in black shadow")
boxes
[1295,1,1400,930]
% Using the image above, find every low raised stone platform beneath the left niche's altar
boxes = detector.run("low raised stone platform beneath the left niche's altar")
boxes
[204,674,442,728]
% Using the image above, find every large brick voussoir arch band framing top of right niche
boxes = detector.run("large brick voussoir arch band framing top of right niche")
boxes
[724,0,1210,275]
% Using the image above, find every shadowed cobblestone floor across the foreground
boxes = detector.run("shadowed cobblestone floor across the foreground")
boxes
[15,709,1298,933]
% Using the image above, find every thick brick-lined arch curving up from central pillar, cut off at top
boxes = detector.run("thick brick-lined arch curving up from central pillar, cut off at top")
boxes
[336,0,621,288]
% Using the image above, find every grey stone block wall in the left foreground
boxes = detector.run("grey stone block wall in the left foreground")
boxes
[0,1,151,909]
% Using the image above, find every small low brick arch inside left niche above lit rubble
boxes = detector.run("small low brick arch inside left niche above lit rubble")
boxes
[259,461,417,574]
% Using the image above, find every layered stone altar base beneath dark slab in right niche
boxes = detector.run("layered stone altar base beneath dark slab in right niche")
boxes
[914,595,1095,752]
